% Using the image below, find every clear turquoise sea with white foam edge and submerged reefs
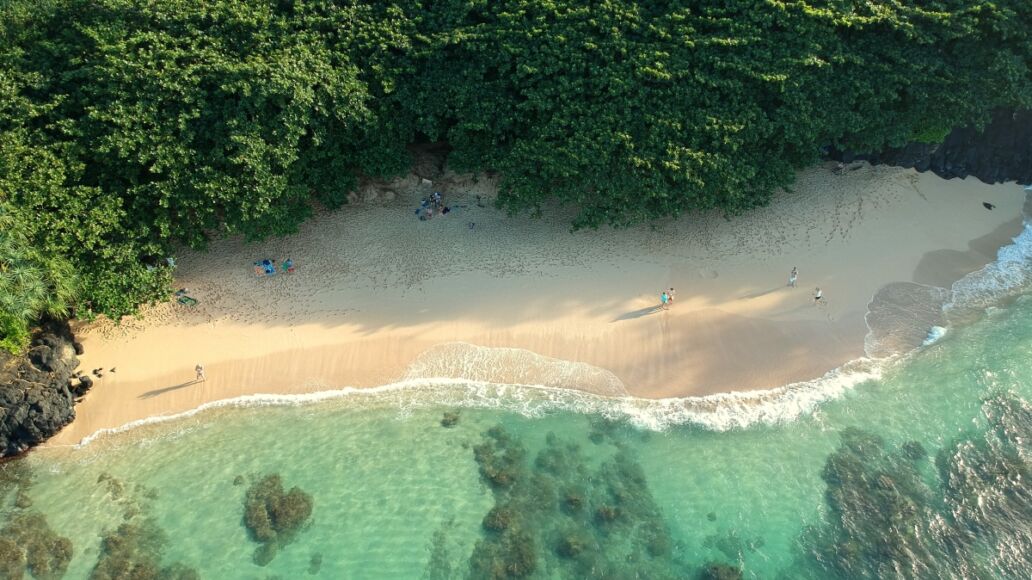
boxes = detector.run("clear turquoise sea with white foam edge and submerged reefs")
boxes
[0,219,1032,578]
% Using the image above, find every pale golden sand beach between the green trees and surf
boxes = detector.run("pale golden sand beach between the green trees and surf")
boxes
[52,164,1025,445]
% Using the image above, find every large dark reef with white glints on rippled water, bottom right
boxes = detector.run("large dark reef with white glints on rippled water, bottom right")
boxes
[800,393,1032,578]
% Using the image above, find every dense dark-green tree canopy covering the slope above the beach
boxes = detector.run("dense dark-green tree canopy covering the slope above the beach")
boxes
[0,0,1032,326]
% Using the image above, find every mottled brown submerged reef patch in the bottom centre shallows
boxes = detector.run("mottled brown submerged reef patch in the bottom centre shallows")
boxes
[469,422,688,579]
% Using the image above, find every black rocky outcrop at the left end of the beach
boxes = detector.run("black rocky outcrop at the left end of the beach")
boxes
[0,323,78,456]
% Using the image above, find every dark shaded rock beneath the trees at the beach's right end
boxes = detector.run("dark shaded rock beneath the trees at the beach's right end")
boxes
[830,106,1032,184]
